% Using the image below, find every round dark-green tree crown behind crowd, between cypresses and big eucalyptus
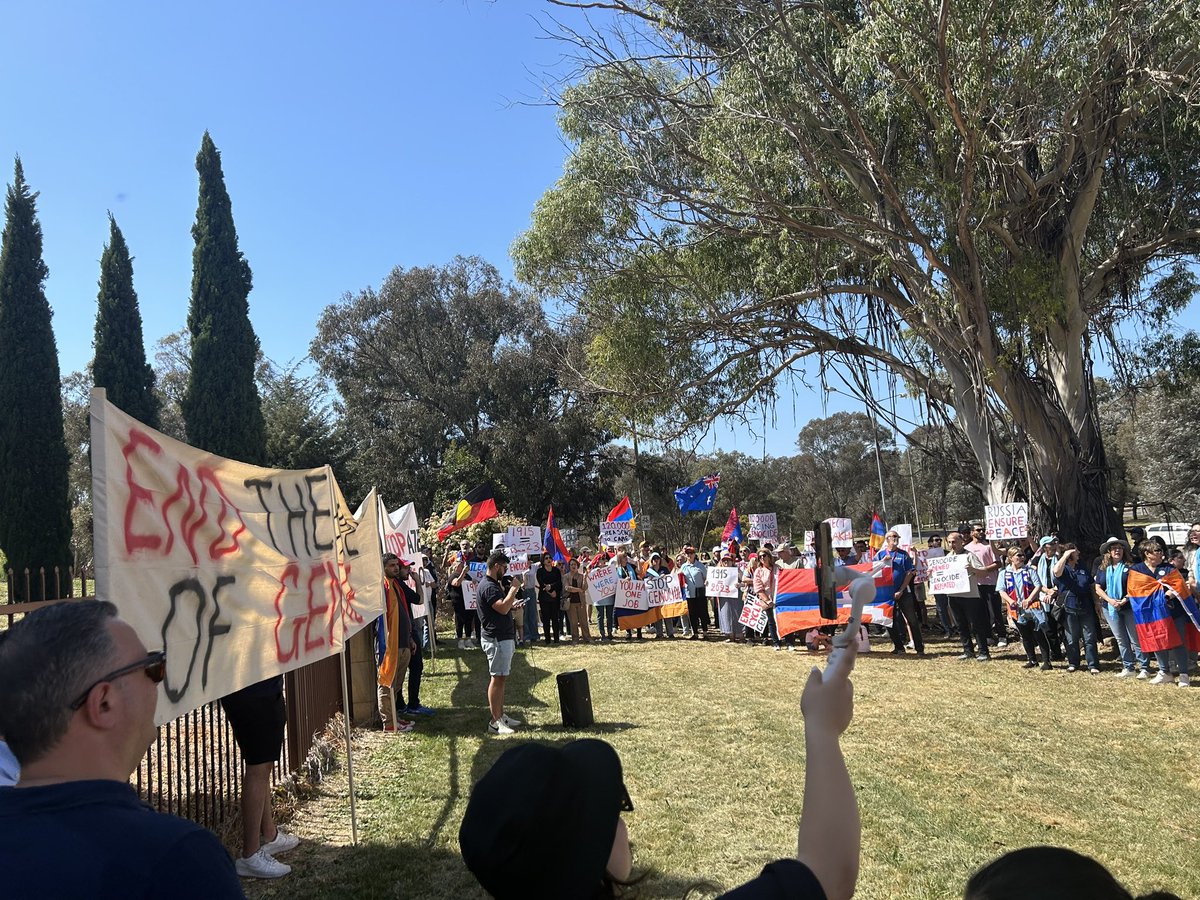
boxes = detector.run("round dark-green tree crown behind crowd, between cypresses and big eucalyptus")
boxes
[311,257,613,526]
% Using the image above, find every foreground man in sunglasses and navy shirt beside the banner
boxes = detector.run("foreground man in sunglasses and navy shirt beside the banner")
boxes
[0,600,244,900]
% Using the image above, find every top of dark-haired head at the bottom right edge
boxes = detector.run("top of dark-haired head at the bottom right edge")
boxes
[962,847,1178,900]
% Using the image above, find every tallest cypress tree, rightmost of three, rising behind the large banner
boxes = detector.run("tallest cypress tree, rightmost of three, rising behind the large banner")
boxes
[181,132,266,463]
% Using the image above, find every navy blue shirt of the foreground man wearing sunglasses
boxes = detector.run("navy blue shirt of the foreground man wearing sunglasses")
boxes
[0,780,245,900]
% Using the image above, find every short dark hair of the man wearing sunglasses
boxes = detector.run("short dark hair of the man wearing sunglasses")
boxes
[0,600,116,766]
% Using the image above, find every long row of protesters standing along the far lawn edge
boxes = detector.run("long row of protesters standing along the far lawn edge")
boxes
[424,523,1200,686]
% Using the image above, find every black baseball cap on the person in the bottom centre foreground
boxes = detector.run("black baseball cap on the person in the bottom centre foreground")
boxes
[458,738,634,900]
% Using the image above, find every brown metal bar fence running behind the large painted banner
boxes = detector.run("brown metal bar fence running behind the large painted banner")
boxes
[0,570,342,829]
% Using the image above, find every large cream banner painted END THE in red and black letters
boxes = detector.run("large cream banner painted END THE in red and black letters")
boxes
[91,389,383,725]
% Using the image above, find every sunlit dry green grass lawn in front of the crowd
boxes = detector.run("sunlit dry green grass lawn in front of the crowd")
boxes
[246,641,1200,900]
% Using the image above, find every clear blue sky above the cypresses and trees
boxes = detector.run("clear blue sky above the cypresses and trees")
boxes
[0,0,835,454]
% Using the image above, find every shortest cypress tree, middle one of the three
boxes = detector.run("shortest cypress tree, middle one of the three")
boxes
[91,212,158,428]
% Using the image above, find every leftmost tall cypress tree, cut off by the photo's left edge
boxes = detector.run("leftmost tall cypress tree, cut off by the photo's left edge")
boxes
[0,157,71,600]
